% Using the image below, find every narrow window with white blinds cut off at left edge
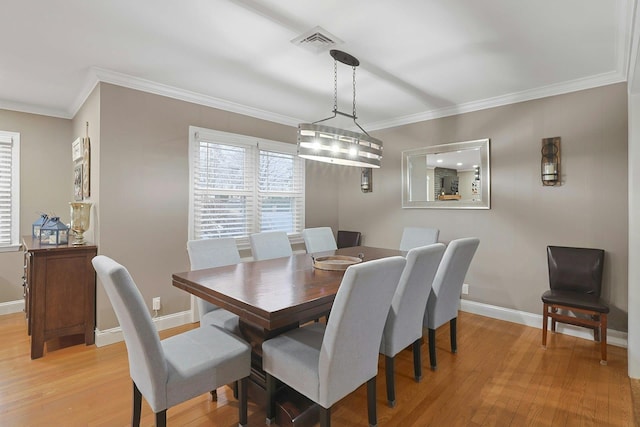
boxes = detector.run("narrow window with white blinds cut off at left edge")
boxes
[0,131,20,252]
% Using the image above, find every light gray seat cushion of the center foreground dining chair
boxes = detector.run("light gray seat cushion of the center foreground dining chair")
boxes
[262,323,325,403]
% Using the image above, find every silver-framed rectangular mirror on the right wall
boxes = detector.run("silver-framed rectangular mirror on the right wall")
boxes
[402,138,491,209]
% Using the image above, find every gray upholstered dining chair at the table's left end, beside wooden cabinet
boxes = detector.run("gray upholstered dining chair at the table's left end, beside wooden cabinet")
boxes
[92,255,251,426]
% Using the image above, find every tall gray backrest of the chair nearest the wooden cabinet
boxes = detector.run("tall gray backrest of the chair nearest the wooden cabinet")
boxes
[91,255,169,407]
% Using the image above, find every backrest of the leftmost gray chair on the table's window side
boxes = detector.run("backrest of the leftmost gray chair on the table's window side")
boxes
[187,237,240,316]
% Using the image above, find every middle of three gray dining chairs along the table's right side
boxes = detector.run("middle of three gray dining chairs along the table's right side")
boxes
[380,243,445,407]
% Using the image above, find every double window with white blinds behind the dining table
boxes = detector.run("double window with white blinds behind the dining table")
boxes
[189,126,305,249]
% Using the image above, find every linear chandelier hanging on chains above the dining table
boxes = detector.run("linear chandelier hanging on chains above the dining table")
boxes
[298,49,382,168]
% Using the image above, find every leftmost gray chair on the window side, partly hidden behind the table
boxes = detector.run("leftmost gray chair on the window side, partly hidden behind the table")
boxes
[187,237,240,336]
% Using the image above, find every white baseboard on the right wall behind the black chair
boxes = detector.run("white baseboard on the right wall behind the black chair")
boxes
[460,299,627,348]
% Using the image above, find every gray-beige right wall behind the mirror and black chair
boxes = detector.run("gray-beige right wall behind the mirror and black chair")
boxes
[338,84,628,331]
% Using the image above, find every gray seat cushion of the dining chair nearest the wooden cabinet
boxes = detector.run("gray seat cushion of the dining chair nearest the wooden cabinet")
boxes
[160,326,251,412]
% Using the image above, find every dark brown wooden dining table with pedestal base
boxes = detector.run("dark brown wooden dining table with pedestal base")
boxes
[172,246,406,426]
